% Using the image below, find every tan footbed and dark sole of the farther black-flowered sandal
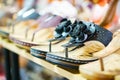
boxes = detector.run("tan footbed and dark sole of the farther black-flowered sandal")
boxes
[30,38,69,59]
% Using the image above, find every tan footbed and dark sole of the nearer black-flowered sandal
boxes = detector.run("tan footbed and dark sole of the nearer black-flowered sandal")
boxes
[46,41,104,70]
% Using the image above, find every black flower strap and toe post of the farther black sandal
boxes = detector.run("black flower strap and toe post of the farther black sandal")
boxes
[49,18,72,52]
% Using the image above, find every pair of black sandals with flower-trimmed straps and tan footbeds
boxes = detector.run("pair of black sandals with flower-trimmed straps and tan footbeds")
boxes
[31,19,112,70]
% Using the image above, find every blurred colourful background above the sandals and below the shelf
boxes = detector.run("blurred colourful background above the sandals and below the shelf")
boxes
[0,0,120,80]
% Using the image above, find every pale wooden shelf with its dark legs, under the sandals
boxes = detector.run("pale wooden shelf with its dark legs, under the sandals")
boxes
[0,36,120,80]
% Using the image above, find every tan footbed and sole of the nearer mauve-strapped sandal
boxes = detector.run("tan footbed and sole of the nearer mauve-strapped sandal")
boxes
[9,28,54,50]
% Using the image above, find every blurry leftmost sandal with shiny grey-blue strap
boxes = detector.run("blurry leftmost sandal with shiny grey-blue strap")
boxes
[0,9,40,37]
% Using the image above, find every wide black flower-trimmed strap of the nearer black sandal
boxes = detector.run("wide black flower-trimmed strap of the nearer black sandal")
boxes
[63,21,112,47]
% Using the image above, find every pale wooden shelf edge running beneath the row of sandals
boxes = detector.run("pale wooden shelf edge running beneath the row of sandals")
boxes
[0,37,86,80]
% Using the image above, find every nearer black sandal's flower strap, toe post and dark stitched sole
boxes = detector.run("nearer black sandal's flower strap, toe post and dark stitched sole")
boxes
[46,21,112,70]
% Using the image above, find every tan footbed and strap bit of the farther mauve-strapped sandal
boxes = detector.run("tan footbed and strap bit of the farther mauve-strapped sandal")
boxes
[11,13,51,35]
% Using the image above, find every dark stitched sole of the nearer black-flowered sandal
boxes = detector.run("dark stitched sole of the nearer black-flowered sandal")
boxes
[46,54,98,70]
